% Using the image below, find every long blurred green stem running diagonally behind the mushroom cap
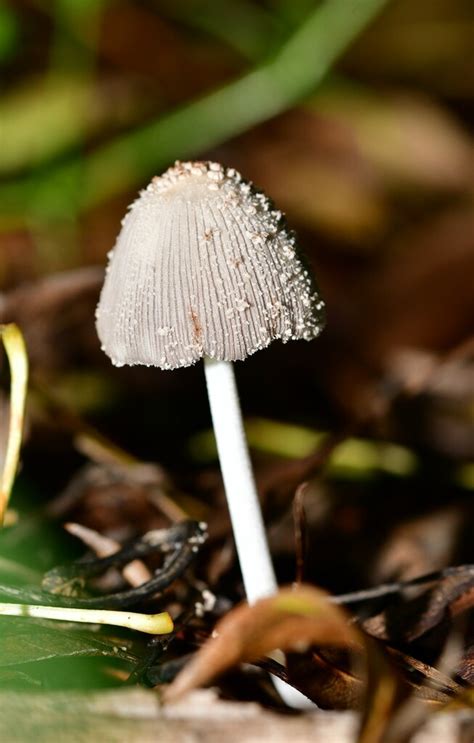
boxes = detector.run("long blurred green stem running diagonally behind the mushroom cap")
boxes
[0,0,388,225]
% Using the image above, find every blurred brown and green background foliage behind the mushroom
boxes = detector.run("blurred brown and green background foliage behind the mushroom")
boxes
[0,0,474,604]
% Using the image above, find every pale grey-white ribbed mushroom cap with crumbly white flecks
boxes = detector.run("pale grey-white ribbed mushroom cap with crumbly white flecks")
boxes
[96,162,324,369]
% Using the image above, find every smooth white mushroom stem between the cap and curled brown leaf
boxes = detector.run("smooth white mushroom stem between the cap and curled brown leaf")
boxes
[204,358,277,604]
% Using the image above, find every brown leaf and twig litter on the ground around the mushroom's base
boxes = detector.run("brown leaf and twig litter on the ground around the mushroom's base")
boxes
[0,296,474,743]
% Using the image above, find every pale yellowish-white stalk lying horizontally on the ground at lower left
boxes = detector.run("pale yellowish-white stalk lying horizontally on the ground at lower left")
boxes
[0,603,173,635]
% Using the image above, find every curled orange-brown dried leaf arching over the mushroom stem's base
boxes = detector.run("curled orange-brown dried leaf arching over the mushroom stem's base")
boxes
[164,586,406,743]
